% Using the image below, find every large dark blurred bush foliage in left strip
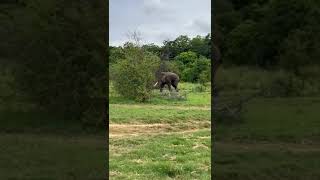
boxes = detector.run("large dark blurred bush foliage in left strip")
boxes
[5,0,106,126]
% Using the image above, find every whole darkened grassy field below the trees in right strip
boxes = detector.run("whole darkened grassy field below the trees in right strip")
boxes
[213,66,320,180]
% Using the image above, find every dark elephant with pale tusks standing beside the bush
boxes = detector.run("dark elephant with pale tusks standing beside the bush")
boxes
[154,72,179,92]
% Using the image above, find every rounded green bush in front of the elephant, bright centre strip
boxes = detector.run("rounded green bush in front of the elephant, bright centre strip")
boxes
[113,44,160,102]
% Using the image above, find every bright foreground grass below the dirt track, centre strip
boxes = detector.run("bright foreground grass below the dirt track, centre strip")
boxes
[109,130,211,180]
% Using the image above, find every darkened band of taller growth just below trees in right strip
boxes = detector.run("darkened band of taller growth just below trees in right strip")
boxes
[217,66,320,97]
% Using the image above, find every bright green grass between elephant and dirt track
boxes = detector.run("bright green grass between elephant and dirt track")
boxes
[109,83,211,123]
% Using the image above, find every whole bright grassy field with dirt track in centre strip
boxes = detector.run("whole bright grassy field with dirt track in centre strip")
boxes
[109,83,211,179]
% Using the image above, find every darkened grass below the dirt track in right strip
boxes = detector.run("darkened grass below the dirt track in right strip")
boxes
[213,143,320,180]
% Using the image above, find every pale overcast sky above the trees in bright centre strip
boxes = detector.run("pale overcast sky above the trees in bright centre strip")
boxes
[109,0,211,46]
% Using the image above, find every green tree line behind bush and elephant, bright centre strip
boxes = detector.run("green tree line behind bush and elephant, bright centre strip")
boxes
[109,33,211,83]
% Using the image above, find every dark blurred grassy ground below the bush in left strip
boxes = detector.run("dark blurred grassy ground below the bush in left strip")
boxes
[0,111,107,179]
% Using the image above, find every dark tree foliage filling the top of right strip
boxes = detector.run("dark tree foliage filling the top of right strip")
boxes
[214,0,320,68]
